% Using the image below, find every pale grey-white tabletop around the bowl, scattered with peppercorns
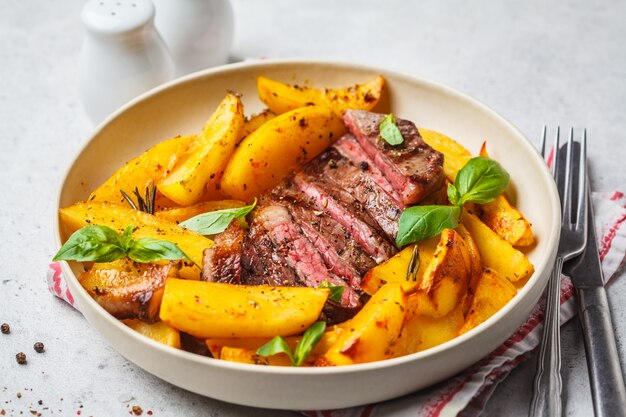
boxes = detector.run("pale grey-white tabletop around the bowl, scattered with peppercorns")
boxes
[0,0,626,416]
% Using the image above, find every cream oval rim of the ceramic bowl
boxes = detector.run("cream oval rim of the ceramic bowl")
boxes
[52,59,561,377]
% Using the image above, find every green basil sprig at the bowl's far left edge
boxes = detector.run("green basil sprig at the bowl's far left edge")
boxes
[52,225,193,263]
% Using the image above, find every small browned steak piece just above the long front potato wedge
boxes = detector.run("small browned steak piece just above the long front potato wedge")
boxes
[202,221,245,284]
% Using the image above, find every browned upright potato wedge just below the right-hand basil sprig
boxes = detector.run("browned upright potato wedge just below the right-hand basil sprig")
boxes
[416,229,472,318]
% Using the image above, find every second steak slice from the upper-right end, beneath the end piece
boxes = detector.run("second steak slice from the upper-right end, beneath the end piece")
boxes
[311,144,402,241]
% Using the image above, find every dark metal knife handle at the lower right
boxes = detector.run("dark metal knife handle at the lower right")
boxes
[576,287,626,417]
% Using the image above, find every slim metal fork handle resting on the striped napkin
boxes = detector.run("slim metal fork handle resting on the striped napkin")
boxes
[530,256,563,417]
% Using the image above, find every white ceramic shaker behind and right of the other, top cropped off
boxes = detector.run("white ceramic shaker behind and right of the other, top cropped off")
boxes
[153,0,234,77]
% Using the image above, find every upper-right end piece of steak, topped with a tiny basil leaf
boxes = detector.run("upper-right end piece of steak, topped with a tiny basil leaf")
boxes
[343,110,444,205]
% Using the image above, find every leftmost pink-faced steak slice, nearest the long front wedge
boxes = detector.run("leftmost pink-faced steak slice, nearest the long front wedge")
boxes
[254,201,360,307]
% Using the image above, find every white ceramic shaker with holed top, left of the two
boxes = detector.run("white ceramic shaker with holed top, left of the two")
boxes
[79,0,174,124]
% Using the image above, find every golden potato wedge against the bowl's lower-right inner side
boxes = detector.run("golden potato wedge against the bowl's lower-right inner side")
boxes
[459,269,517,333]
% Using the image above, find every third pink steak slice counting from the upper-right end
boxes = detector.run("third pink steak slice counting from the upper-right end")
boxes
[293,172,397,263]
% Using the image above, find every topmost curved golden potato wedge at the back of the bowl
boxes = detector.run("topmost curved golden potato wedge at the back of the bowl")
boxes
[257,75,385,115]
